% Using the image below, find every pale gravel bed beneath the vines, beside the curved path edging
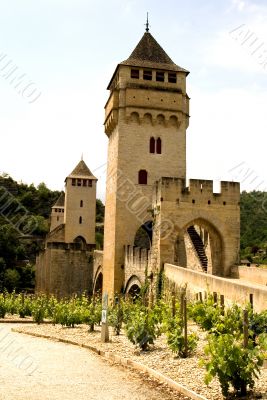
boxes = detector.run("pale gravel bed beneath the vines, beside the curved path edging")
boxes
[8,318,267,400]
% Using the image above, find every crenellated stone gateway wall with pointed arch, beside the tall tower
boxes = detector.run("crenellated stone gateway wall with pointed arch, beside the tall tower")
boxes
[151,178,240,276]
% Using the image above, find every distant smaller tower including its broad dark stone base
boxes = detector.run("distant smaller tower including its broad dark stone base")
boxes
[35,160,97,297]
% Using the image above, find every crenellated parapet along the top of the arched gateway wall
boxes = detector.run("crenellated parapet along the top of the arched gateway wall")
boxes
[154,177,240,206]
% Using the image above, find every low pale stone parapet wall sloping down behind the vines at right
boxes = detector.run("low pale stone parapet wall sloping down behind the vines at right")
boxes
[164,264,267,312]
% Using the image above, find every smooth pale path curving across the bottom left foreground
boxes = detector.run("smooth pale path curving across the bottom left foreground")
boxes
[0,324,187,400]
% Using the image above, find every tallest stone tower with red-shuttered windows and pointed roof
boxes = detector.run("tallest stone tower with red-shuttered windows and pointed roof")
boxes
[103,27,189,295]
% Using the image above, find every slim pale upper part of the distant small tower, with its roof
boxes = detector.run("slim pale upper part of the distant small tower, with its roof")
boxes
[64,160,97,244]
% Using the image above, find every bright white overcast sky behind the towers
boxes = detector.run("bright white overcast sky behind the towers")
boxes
[0,0,267,199]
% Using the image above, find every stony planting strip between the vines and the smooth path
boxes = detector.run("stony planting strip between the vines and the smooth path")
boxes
[11,325,267,400]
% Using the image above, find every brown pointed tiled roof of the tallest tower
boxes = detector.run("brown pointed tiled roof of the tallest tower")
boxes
[121,32,189,74]
